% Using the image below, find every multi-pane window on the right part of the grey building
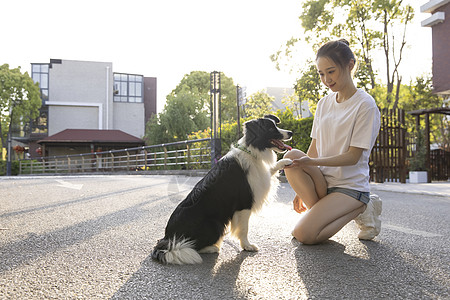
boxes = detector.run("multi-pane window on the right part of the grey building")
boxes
[114,73,144,103]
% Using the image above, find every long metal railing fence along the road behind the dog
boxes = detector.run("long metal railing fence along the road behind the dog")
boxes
[19,138,211,175]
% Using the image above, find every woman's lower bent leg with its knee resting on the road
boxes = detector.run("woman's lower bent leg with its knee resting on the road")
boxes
[292,193,365,244]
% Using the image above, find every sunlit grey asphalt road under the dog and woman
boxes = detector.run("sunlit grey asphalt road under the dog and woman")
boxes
[0,176,450,299]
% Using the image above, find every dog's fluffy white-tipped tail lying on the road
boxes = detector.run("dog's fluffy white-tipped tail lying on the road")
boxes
[152,237,202,265]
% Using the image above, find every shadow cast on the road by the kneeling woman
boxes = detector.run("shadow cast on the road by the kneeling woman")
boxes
[292,240,448,299]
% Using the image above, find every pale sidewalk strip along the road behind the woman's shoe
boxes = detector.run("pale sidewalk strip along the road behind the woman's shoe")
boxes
[370,181,450,199]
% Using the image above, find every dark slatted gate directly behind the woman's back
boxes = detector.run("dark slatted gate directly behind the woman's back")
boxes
[369,108,407,183]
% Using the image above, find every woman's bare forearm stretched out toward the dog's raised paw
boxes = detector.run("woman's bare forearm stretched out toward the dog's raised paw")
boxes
[286,145,364,168]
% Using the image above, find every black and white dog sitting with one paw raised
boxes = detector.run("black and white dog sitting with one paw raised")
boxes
[152,115,292,264]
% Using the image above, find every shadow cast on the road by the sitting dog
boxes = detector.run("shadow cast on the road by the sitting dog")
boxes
[111,240,255,299]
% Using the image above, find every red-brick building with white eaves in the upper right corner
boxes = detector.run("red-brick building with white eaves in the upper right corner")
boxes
[420,0,450,95]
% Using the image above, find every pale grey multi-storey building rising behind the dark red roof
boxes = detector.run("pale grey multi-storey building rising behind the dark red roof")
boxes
[22,59,157,157]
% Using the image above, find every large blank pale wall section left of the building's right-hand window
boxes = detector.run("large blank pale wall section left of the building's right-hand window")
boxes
[47,60,113,135]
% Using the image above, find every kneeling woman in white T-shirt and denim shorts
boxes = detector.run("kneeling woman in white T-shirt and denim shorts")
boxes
[285,40,381,244]
